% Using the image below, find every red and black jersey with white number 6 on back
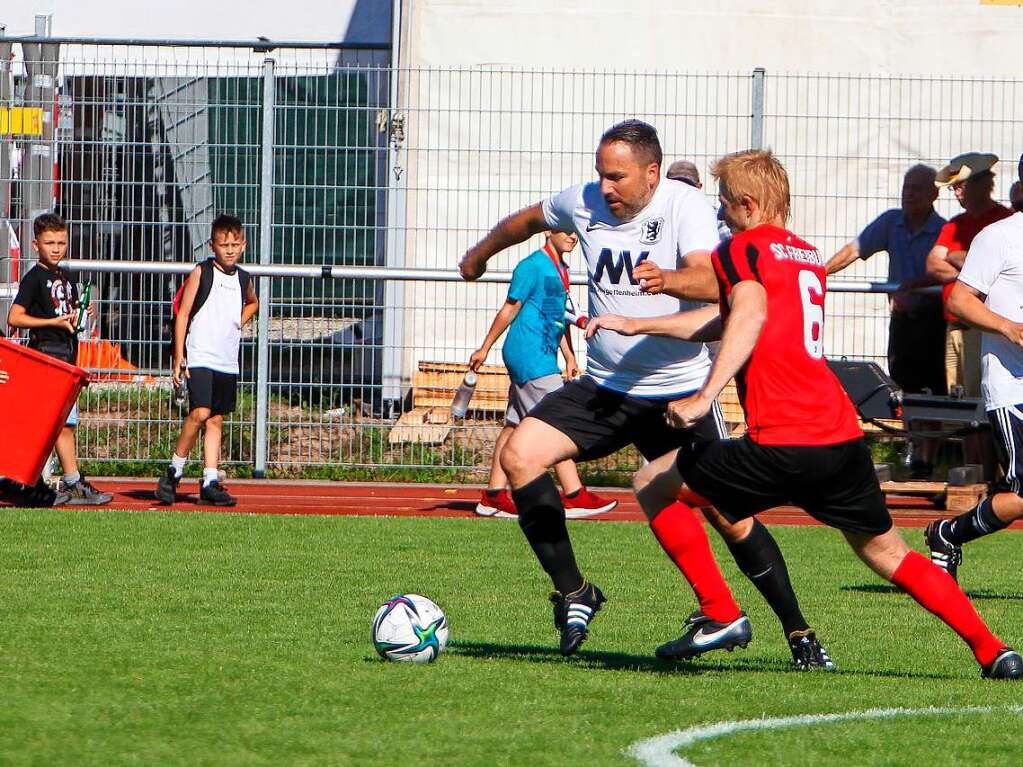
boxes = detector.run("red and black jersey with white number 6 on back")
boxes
[713,224,863,445]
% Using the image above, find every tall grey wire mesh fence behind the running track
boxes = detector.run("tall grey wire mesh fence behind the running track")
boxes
[0,38,1023,480]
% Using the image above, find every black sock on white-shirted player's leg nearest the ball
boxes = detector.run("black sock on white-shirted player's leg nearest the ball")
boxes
[512,471,583,594]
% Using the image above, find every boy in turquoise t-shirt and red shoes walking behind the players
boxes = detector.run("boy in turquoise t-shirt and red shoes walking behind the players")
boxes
[469,232,618,518]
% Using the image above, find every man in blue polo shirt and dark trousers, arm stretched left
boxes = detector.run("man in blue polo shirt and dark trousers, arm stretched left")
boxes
[828,165,947,479]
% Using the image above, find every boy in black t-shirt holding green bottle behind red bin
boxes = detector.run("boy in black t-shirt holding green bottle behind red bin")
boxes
[7,213,114,506]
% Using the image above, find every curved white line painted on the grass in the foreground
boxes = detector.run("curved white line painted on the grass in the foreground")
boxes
[625,706,1023,767]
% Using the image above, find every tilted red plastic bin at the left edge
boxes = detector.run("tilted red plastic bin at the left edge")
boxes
[0,339,89,485]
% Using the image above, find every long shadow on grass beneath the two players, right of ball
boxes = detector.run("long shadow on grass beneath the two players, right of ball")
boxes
[447,641,958,679]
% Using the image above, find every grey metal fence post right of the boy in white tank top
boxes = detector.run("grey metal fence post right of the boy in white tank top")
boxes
[253,58,276,478]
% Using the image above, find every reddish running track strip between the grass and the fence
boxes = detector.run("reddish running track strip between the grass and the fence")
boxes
[6,479,1023,528]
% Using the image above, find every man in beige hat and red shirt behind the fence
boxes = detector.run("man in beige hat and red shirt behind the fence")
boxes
[927,151,1013,480]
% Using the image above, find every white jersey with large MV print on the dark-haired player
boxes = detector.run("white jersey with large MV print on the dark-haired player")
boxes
[542,179,719,398]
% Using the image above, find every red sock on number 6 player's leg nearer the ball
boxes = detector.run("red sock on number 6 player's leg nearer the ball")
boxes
[650,501,741,623]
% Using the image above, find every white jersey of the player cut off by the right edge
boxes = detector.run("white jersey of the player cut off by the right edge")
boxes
[959,213,1023,410]
